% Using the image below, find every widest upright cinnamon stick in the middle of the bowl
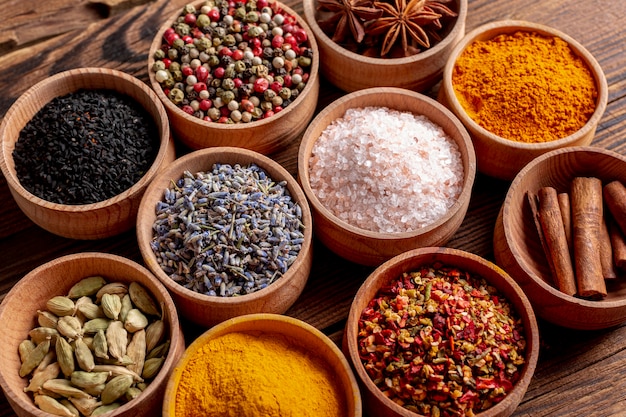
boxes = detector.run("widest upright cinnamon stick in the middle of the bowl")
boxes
[570,177,606,298]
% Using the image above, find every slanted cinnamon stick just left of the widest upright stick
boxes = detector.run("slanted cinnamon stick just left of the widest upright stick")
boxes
[537,187,576,295]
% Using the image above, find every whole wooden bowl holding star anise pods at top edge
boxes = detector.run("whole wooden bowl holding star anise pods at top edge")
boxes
[303,0,467,92]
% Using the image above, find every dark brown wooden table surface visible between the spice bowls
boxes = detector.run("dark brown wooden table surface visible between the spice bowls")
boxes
[0,0,626,417]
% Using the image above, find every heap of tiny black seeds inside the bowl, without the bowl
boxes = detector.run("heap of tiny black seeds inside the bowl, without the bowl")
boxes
[13,90,159,205]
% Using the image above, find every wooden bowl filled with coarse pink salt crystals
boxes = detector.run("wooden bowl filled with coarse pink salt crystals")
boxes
[298,87,476,266]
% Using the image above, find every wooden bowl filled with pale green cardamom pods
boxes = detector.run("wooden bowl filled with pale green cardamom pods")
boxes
[0,252,185,417]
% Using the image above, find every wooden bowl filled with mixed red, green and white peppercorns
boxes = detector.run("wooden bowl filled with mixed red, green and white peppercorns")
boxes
[148,0,320,154]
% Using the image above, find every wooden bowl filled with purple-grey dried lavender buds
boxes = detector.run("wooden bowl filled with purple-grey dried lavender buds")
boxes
[136,147,313,327]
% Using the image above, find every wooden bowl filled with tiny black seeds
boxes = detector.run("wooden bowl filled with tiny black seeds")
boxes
[0,68,175,239]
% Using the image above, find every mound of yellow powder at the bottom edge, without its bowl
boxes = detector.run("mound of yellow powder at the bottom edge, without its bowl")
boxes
[175,333,347,417]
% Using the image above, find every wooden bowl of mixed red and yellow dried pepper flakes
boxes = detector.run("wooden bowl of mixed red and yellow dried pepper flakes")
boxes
[343,247,539,417]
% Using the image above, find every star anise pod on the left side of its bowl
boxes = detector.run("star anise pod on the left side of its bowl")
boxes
[318,0,383,43]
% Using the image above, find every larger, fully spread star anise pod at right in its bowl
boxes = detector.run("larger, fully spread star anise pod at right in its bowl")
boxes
[366,0,456,56]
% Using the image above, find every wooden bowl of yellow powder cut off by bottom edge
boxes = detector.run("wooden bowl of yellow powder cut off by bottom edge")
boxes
[163,313,362,417]
